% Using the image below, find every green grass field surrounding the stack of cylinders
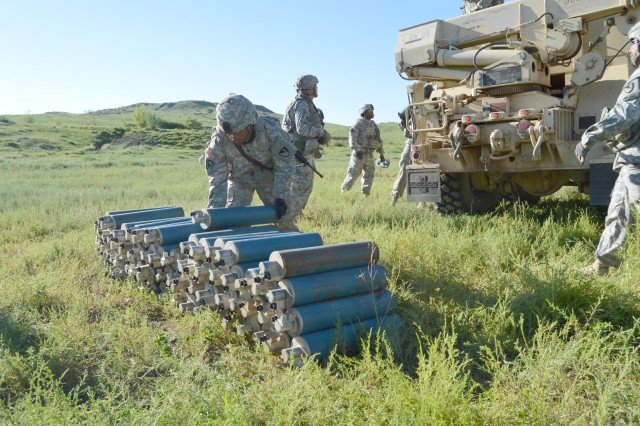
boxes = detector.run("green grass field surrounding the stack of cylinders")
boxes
[0,108,640,425]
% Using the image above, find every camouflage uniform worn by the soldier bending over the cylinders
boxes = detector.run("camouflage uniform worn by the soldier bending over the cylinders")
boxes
[207,117,296,226]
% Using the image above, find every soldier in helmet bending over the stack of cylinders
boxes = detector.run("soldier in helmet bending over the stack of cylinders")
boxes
[207,94,296,229]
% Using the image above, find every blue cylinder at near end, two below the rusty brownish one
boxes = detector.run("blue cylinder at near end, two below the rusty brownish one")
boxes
[274,290,396,337]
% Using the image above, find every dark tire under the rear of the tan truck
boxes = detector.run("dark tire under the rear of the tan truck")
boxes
[437,173,501,214]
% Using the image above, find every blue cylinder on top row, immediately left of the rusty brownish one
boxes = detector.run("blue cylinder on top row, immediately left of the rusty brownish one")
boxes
[216,232,322,265]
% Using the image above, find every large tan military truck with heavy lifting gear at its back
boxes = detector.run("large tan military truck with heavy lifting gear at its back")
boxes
[395,0,640,213]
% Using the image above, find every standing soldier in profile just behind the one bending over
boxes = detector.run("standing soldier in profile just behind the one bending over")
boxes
[282,75,331,228]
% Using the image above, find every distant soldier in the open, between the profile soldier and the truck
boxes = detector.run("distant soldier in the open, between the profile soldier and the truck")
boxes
[342,104,385,197]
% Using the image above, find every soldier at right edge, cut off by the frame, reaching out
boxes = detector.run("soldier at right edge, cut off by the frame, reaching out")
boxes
[575,23,640,275]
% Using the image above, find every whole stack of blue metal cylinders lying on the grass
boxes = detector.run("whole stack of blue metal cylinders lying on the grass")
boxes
[95,205,403,365]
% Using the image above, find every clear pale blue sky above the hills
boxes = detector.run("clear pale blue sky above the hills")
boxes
[0,0,470,125]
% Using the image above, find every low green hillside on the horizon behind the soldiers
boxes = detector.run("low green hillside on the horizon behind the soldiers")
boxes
[0,101,402,157]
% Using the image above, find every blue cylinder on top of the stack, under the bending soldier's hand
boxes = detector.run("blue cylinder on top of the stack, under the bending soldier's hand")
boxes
[191,205,278,229]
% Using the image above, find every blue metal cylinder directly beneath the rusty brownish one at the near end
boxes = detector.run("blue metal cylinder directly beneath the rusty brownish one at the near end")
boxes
[267,265,387,309]
